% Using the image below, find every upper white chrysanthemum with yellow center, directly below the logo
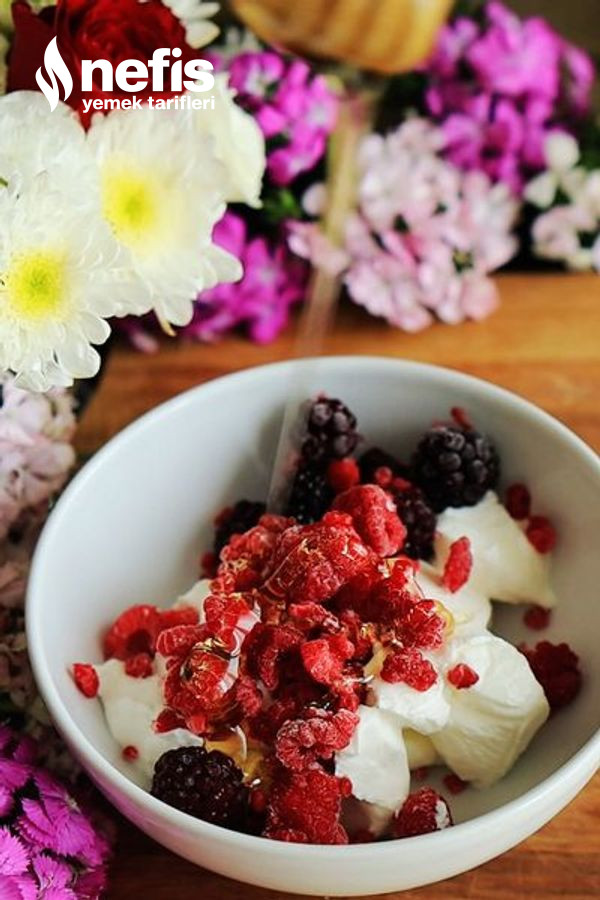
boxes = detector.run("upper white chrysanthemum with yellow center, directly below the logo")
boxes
[88,107,242,328]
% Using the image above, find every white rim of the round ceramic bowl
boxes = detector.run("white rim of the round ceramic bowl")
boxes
[26,354,600,861]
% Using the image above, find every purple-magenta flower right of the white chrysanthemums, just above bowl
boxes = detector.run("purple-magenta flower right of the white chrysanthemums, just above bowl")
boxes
[183,213,307,344]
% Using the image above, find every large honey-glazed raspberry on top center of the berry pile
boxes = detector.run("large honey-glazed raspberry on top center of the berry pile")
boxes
[264,513,371,603]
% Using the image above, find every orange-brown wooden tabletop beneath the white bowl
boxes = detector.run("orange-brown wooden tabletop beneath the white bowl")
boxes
[78,275,600,900]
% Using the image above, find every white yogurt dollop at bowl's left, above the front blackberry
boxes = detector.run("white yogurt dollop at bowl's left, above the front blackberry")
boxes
[95,659,203,790]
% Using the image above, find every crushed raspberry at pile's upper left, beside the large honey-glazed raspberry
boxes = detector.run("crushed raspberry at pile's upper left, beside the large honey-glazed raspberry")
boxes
[217,515,293,591]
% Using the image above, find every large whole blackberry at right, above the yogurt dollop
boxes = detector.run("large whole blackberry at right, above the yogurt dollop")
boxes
[413,425,500,512]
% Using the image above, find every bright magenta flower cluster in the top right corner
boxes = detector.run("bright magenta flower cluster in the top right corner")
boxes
[425,0,594,194]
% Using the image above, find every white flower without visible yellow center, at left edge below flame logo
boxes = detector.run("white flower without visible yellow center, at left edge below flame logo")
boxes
[0,91,91,202]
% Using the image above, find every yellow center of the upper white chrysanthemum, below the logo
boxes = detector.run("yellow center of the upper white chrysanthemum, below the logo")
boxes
[102,165,168,252]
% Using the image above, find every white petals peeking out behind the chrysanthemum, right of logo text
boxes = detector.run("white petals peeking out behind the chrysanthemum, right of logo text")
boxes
[188,73,265,207]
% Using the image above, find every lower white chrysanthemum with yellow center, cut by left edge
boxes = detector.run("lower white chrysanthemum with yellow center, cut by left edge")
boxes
[0,175,120,391]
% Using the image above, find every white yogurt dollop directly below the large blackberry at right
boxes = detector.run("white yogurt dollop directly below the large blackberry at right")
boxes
[435,491,556,608]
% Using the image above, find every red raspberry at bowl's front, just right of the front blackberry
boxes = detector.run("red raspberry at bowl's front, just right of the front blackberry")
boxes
[263,768,348,844]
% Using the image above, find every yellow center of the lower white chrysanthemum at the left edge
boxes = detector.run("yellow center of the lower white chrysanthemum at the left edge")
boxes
[1,250,68,322]
